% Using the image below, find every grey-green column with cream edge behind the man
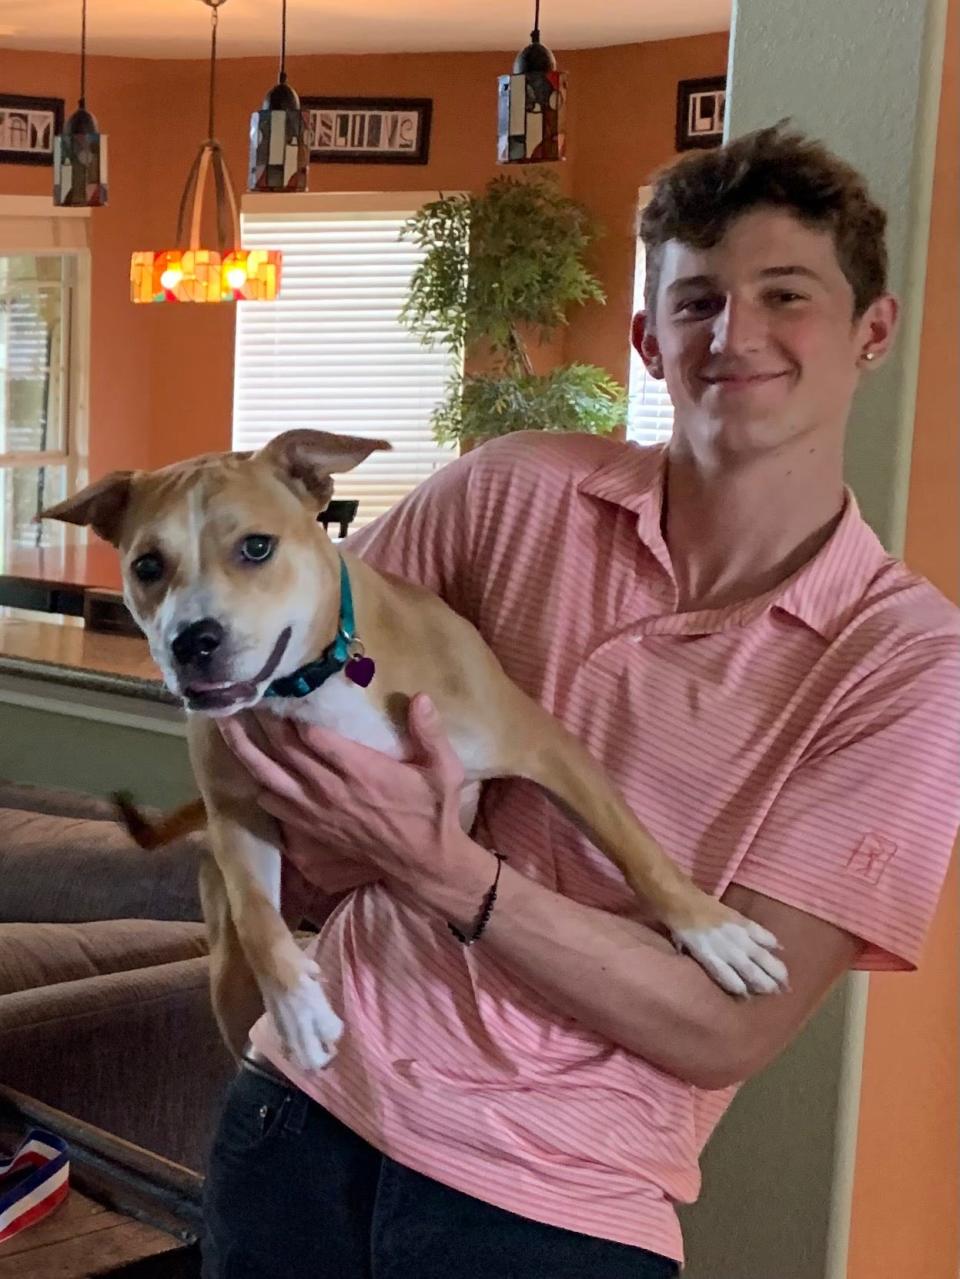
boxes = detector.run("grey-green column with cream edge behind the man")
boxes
[683,0,946,1279]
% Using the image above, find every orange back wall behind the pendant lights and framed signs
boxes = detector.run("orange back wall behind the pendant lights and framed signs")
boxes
[0,39,726,476]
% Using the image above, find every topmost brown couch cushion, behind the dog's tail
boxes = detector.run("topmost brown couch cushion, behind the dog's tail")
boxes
[0,808,203,923]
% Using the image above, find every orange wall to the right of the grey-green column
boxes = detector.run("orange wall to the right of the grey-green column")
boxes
[848,0,960,1279]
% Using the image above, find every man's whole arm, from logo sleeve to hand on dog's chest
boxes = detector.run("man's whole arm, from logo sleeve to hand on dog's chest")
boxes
[221,647,960,1087]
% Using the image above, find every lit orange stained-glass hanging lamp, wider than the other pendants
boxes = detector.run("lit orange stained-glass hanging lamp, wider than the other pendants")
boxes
[130,0,281,302]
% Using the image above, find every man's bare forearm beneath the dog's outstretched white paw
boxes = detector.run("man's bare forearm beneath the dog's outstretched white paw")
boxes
[422,836,862,1088]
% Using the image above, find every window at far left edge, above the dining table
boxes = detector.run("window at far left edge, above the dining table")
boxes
[0,197,88,555]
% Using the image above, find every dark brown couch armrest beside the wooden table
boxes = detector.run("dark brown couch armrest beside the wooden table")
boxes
[0,958,234,1172]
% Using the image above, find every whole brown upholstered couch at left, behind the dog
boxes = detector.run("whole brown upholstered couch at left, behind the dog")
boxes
[0,781,233,1172]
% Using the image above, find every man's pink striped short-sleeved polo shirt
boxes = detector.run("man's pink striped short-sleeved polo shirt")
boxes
[253,434,960,1259]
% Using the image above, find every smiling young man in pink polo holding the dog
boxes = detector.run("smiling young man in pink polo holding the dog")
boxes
[206,129,960,1279]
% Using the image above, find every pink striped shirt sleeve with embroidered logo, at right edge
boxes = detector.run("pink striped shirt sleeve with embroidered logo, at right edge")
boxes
[732,638,960,971]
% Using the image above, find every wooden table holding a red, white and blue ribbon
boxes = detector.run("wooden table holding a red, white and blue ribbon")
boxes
[0,1087,203,1279]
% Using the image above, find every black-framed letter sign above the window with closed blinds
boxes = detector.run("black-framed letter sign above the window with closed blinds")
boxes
[300,97,433,164]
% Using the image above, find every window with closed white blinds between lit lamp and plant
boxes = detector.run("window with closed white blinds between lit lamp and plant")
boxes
[233,193,456,527]
